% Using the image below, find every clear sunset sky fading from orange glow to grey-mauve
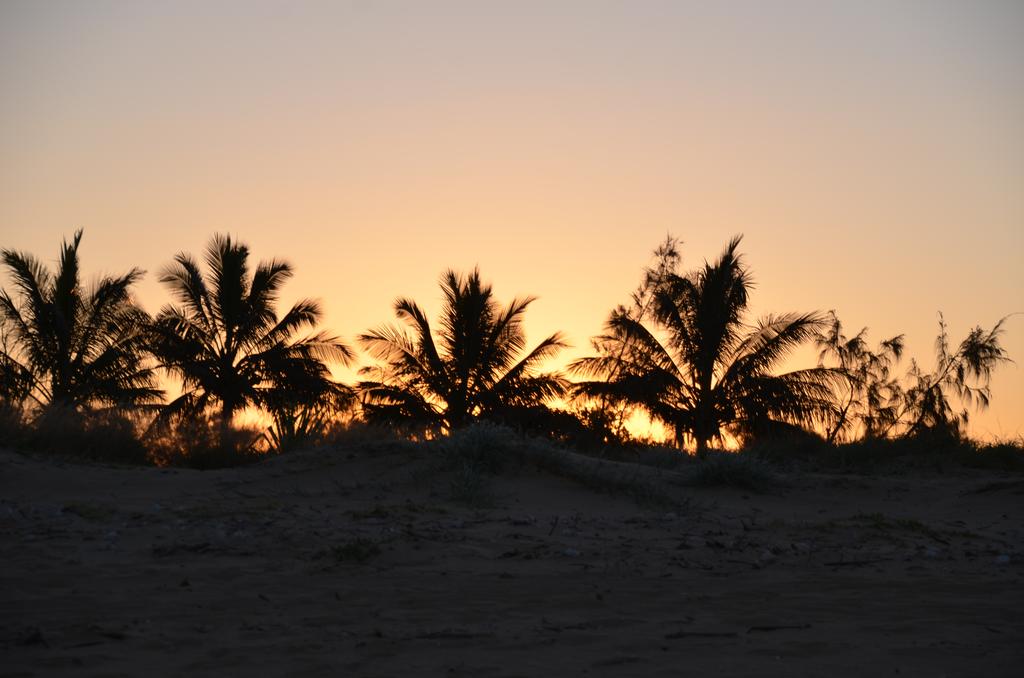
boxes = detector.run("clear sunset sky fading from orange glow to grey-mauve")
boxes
[0,0,1024,438]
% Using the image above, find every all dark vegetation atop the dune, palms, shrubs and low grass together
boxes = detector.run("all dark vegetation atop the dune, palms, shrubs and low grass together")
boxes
[0,231,1024,475]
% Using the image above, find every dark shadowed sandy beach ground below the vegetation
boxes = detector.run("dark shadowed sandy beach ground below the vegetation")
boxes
[0,446,1024,676]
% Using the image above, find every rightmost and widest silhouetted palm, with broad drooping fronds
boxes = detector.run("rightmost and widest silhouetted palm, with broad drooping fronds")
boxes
[570,237,837,456]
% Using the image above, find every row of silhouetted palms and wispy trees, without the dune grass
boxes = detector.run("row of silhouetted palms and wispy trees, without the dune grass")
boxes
[0,230,1009,456]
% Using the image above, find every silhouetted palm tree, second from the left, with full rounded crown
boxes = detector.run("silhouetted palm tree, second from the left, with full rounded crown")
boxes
[153,236,352,446]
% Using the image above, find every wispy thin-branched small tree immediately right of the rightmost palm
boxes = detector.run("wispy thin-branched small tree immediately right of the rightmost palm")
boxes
[814,310,903,442]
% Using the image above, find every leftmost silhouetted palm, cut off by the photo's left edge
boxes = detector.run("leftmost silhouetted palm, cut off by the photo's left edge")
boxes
[0,229,163,414]
